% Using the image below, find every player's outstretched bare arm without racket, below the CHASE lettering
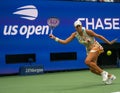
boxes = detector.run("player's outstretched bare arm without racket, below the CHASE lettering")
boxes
[87,30,117,45]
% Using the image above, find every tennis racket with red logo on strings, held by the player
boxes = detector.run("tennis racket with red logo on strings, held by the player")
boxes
[47,17,60,34]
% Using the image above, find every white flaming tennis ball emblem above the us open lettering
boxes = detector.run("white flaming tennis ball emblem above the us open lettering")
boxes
[13,5,38,20]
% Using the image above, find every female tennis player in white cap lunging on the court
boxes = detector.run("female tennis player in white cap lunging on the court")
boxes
[49,20,117,84]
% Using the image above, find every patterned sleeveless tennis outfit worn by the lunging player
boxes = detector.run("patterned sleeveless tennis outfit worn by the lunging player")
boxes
[75,29,104,55]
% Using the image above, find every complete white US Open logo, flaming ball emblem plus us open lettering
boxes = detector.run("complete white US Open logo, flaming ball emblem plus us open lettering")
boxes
[3,5,49,39]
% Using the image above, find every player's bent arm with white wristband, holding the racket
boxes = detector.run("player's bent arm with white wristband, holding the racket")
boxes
[49,32,76,44]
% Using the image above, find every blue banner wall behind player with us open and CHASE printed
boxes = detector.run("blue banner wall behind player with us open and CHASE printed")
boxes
[0,0,120,74]
